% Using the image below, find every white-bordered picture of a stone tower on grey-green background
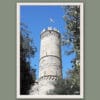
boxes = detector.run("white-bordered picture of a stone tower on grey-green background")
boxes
[16,2,84,99]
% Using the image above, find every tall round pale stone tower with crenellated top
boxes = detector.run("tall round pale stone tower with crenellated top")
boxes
[39,27,62,95]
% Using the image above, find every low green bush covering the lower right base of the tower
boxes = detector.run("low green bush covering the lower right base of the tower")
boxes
[48,75,80,95]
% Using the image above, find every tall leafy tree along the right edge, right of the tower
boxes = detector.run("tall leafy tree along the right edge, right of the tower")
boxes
[62,6,80,94]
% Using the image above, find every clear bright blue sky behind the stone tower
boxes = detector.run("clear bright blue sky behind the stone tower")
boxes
[20,5,74,79]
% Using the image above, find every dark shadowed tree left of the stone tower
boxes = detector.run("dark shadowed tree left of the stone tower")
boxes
[20,23,36,94]
